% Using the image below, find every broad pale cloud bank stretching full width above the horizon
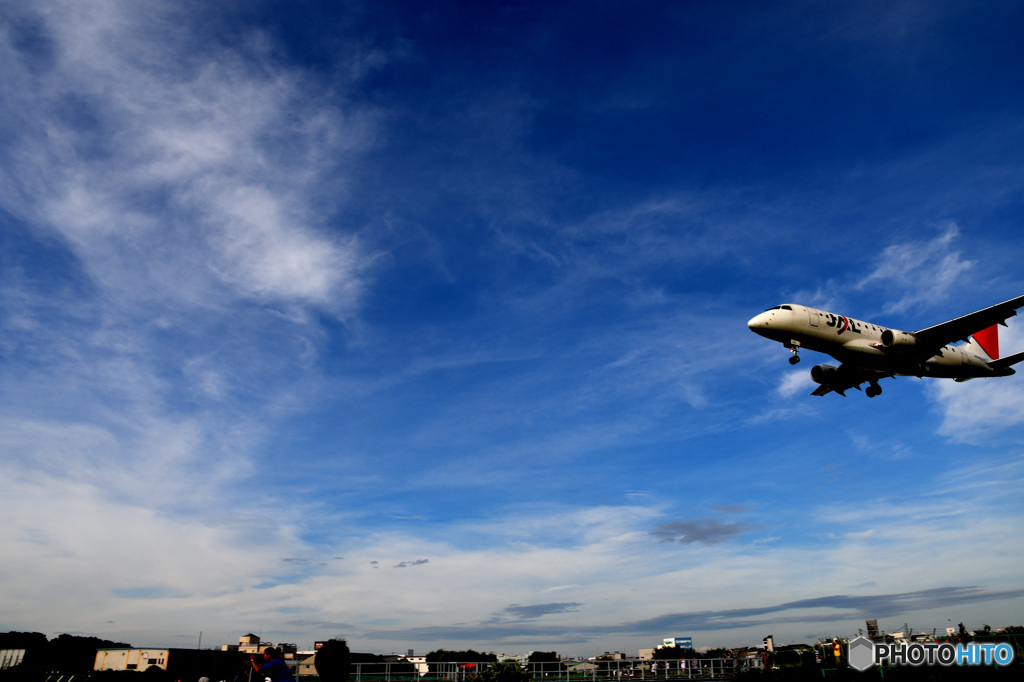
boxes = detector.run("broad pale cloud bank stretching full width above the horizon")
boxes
[0,436,1022,652]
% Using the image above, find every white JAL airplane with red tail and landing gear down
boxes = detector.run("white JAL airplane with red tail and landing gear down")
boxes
[746,296,1024,397]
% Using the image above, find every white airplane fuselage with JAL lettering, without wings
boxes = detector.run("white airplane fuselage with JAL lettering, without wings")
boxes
[746,303,998,379]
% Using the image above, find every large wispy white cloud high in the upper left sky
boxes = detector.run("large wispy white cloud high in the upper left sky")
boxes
[0,2,373,314]
